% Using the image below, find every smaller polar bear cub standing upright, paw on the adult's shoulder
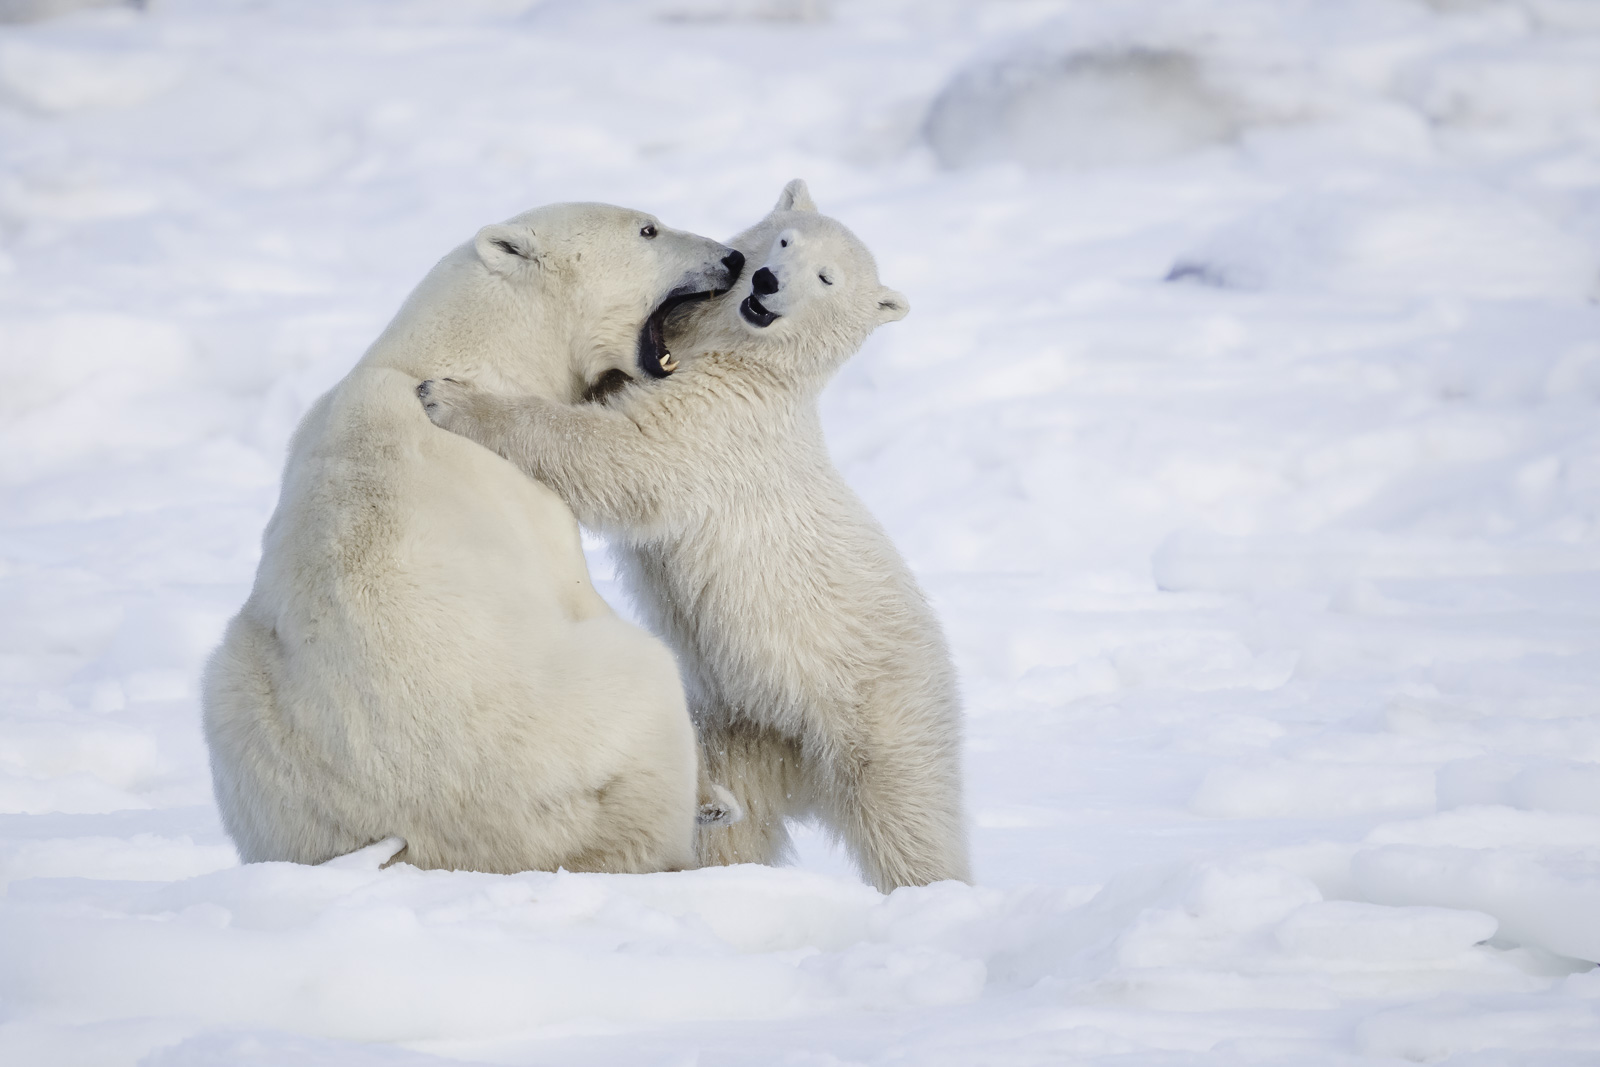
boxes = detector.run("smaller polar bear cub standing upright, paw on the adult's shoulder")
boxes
[419,181,968,891]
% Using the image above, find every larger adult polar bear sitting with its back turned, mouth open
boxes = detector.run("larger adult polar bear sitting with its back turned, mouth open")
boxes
[202,205,744,872]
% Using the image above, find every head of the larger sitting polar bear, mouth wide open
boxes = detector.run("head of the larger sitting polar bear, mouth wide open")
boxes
[474,203,744,381]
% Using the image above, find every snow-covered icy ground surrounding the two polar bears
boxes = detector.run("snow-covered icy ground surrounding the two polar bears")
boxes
[0,0,1600,1067]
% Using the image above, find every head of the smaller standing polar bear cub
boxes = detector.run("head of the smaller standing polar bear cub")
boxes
[725,179,910,379]
